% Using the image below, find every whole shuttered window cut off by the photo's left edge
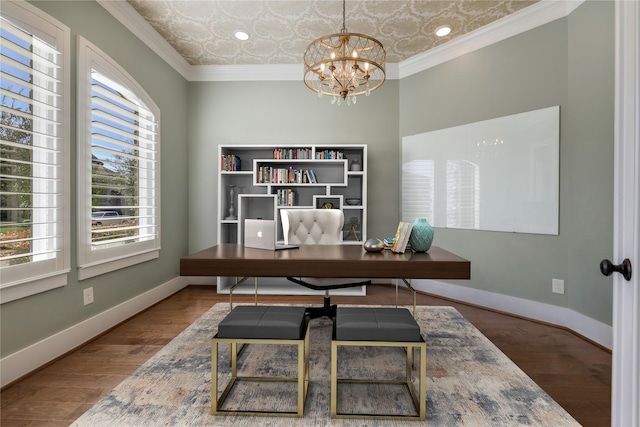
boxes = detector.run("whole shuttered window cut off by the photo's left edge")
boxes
[0,1,71,303]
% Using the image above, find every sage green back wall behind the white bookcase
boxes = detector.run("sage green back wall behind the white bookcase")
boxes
[189,80,399,252]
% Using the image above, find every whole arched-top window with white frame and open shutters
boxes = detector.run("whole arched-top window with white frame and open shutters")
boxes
[78,38,160,280]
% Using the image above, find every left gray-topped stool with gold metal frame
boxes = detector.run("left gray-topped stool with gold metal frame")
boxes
[211,306,309,417]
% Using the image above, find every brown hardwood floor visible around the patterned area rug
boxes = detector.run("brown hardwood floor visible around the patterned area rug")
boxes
[0,285,611,427]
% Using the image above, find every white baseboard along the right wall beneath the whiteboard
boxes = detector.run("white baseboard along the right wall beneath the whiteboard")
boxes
[412,280,613,350]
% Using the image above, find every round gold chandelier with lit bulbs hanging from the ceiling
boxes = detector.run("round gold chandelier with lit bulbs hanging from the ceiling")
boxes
[304,0,386,105]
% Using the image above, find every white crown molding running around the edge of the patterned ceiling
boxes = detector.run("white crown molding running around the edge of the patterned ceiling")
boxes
[96,0,585,81]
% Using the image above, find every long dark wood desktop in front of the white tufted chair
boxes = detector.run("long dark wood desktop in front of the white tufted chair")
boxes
[180,243,471,279]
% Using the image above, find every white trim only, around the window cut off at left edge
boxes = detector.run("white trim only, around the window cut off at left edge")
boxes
[0,1,71,304]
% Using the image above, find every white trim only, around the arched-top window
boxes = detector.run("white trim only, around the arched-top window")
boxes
[77,36,160,280]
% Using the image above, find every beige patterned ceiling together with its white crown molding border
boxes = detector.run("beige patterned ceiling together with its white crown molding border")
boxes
[97,0,583,80]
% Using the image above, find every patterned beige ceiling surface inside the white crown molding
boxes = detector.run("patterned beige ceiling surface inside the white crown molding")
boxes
[127,0,539,65]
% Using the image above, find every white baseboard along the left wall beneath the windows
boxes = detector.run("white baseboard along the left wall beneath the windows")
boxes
[0,277,188,387]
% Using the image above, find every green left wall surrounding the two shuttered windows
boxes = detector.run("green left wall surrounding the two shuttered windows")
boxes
[0,1,188,357]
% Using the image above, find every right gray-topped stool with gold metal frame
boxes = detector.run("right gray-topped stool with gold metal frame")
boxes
[331,306,427,420]
